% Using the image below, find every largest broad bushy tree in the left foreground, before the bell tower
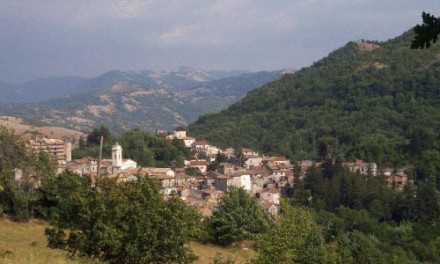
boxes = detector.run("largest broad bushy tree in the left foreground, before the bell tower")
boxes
[46,173,201,263]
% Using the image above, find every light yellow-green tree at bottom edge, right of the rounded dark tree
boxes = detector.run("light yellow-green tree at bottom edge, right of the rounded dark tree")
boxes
[256,203,324,263]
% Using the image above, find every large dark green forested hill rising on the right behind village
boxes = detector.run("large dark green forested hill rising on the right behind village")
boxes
[189,32,440,166]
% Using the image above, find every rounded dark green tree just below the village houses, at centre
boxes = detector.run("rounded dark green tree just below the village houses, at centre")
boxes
[208,188,268,245]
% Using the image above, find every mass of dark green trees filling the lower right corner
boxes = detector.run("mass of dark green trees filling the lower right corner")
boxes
[300,165,440,263]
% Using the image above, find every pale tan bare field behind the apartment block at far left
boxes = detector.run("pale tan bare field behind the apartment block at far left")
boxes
[0,116,85,143]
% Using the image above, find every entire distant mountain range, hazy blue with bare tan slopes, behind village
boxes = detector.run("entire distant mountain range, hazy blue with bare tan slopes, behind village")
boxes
[0,67,284,132]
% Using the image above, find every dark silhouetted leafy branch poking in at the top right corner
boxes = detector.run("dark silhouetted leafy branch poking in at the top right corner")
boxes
[411,12,440,49]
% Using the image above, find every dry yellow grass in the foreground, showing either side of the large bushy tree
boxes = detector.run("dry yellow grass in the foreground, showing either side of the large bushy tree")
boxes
[0,219,255,264]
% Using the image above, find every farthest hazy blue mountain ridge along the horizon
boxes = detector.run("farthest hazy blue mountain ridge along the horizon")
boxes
[0,66,254,103]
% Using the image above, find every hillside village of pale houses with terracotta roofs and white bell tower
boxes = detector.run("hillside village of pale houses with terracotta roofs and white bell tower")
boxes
[24,130,408,216]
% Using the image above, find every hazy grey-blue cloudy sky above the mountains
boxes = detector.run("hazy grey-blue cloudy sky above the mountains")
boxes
[0,0,440,83]
